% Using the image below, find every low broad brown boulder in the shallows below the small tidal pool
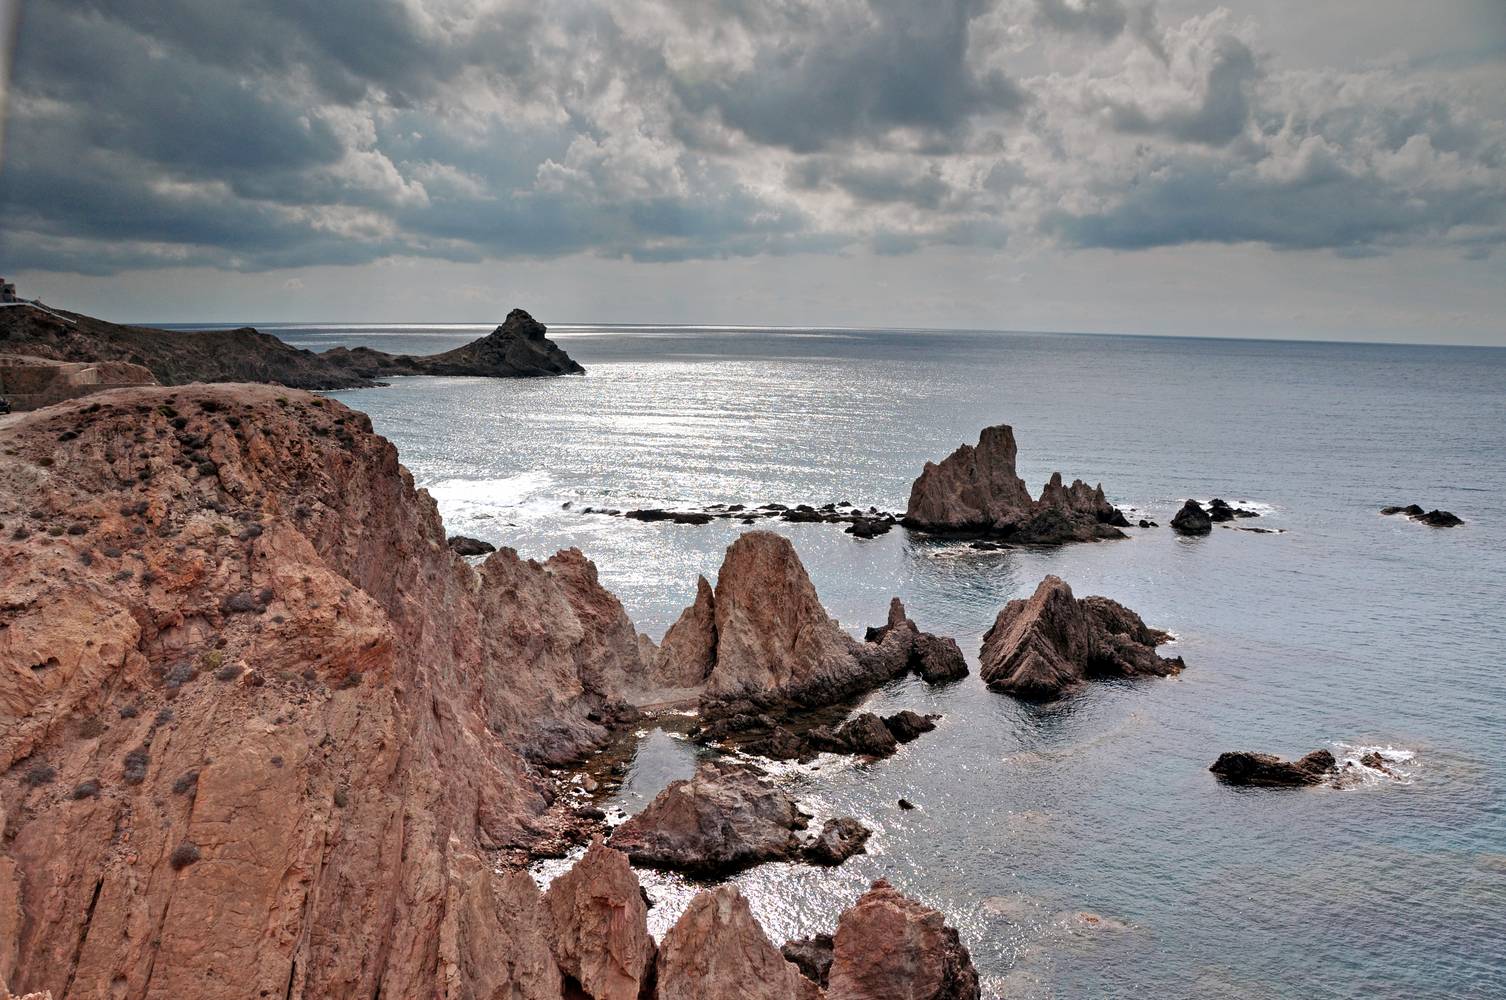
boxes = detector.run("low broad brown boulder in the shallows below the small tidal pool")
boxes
[611,761,809,878]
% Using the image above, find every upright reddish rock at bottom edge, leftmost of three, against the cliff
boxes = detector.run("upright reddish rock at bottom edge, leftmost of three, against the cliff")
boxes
[544,839,655,1000]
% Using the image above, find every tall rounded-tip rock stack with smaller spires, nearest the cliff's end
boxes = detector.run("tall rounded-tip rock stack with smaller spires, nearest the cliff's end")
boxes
[648,532,967,718]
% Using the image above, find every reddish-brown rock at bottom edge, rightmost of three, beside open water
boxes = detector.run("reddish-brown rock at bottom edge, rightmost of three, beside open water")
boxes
[825,880,979,1000]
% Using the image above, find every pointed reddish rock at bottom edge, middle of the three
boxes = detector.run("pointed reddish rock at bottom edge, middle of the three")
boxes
[657,884,825,1000]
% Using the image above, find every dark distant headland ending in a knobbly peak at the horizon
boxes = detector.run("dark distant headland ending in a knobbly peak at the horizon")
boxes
[0,298,584,389]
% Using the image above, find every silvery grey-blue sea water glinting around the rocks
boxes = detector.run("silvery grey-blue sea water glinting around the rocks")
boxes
[271,327,1506,998]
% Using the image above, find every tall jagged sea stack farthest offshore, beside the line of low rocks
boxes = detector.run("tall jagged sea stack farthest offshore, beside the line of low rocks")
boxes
[904,423,1128,545]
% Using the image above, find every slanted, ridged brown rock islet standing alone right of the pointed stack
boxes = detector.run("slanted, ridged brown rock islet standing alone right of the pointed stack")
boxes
[979,577,1185,699]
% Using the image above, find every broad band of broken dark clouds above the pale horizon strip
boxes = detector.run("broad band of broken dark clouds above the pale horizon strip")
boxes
[0,0,1506,274]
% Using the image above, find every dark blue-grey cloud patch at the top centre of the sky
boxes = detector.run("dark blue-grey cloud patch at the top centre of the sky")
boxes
[676,0,1026,152]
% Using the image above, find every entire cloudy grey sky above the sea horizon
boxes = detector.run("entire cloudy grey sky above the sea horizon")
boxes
[0,0,1506,345]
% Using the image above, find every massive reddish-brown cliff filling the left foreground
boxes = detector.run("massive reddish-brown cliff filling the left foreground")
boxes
[0,386,642,1000]
